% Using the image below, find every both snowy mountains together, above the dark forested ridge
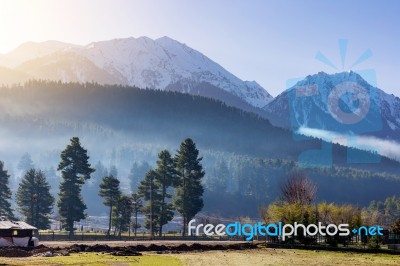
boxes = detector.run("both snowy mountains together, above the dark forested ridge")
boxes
[0,37,400,158]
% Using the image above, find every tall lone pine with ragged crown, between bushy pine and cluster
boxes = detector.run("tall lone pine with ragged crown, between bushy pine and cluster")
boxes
[57,137,95,235]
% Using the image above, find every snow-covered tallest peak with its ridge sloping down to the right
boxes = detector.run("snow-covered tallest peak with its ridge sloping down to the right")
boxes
[49,36,272,107]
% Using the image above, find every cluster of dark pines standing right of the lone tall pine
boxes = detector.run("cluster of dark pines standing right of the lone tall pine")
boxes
[99,139,205,236]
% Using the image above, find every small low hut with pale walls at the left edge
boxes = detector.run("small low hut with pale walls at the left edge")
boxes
[0,216,39,247]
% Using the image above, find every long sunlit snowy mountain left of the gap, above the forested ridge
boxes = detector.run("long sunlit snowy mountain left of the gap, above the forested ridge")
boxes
[0,37,272,109]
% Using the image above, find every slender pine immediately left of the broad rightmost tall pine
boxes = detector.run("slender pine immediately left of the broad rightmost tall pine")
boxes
[155,150,176,236]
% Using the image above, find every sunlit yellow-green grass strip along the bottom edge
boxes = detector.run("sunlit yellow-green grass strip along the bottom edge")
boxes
[0,248,400,266]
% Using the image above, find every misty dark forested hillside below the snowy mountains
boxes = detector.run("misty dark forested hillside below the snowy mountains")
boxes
[0,81,400,215]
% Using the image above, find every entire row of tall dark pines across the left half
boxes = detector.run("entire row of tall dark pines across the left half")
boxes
[0,137,205,236]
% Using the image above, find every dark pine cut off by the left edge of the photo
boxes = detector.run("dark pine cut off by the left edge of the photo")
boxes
[0,161,14,219]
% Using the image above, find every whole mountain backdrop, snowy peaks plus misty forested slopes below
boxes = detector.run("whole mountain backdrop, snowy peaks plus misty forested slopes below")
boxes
[0,37,400,217]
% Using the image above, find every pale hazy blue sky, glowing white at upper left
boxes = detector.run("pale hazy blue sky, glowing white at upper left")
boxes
[0,0,400,96]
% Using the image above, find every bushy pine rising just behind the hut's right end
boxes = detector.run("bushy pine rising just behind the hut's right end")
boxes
[16,169,54,229]
